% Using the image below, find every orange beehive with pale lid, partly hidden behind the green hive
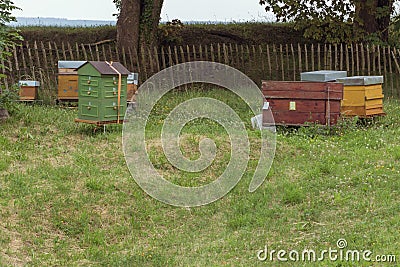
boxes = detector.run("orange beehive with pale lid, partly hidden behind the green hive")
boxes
[57,61,86,101]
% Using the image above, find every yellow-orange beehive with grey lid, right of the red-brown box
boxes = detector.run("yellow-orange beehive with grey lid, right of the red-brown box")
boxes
[338,76,385,118]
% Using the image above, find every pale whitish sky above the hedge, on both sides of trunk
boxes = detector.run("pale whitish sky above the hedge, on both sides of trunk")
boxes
[13,0,272,22]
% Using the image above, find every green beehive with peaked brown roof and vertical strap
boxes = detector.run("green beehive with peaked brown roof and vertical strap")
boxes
[76,61,130,125]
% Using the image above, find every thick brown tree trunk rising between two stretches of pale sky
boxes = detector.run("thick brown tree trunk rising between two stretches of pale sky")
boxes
[117,0,164,51]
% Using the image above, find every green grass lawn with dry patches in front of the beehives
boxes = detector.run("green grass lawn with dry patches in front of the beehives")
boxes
[0,90,400,266]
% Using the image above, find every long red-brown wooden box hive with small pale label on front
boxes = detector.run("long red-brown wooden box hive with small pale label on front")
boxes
[262,81,343,125]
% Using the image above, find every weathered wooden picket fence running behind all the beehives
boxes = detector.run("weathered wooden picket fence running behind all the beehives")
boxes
[0,42,400,103]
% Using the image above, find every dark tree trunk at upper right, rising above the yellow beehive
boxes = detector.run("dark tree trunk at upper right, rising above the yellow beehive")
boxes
[354,0,393,41]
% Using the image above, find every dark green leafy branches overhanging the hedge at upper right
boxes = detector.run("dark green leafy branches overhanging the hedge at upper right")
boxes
[259,0,393,43]
